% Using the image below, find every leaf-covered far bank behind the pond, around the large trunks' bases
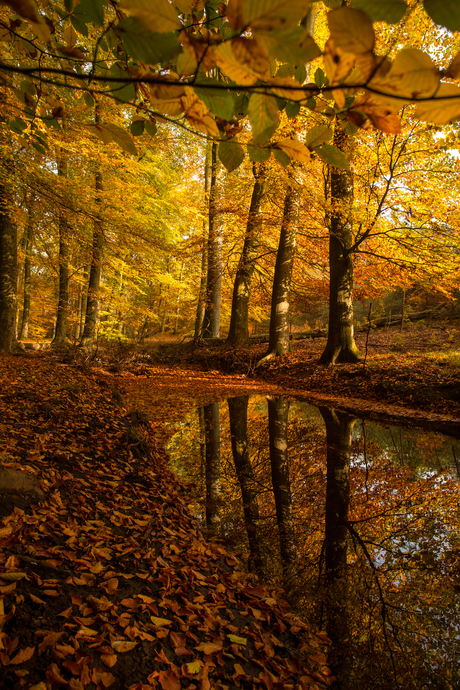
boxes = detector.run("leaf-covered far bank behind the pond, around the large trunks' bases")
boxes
[130,318,460,437]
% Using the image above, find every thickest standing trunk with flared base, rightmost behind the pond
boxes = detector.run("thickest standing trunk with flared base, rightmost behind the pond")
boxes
[319,120,359,366]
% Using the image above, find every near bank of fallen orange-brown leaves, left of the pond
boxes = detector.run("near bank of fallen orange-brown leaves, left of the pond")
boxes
[0,353,333,690]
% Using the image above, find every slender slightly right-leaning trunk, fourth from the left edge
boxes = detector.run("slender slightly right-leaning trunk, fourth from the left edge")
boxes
[80,104,104,351]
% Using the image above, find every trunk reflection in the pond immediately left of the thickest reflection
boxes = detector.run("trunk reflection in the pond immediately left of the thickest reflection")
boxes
[268,398,297,601]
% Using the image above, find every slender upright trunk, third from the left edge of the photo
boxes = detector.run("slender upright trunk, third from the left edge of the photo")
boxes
[51,148,69,346]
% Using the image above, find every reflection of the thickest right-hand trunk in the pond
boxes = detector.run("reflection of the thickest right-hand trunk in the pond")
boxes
[319,407,356,678]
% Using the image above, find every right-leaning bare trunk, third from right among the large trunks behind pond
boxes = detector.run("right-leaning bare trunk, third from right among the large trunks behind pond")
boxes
[227,163,266,347]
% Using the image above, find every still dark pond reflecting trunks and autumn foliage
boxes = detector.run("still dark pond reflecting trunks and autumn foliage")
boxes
[168,396,460,690]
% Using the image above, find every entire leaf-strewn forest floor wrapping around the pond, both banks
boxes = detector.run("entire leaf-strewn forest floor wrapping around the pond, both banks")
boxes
[0,322,460,690]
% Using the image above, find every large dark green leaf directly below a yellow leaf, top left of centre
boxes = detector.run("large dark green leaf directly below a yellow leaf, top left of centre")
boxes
[115,17,182,64]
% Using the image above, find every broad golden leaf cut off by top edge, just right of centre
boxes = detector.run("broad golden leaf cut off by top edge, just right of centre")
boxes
[226,0,310,31]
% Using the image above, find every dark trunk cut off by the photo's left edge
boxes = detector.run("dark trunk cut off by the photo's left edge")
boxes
[0,184,21,352]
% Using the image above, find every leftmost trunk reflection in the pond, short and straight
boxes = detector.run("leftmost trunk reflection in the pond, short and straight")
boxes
[204,403,221,537]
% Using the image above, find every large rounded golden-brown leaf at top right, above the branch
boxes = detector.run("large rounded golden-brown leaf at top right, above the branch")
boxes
[327,7,375,55]
